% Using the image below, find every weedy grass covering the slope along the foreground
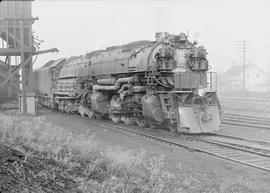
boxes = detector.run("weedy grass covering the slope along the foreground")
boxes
[0,114,268,193]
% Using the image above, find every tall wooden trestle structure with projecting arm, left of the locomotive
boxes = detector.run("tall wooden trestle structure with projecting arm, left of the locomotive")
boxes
[0,0,57,114]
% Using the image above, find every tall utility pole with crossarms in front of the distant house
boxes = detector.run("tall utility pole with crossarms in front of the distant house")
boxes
[236,40,251,91]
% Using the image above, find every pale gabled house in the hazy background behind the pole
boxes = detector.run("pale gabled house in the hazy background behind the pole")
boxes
[219,64,270,91]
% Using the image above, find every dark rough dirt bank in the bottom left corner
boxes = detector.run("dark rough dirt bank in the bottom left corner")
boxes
[0,144,77,193]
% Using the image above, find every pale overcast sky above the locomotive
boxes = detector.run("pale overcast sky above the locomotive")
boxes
[32,0,270,72]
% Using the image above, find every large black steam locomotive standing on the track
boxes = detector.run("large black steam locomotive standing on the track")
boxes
[34,32,221,133]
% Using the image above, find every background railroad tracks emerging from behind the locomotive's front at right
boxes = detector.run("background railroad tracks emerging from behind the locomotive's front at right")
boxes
[222,113,270,129]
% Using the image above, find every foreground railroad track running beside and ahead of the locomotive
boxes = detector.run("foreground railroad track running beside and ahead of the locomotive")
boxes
[75,114,270,172]
